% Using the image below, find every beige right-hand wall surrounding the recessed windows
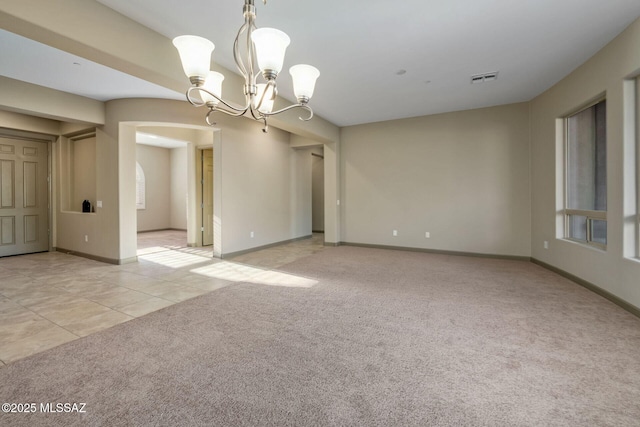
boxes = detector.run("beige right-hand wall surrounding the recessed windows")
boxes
[531,17,640,307]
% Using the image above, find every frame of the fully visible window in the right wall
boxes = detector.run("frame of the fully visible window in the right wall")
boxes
[562,96,608,250]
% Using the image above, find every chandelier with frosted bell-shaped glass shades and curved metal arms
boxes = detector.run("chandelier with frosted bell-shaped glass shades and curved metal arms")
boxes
[173,0,320,132]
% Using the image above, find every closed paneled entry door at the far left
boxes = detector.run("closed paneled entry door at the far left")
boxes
[0,137,49,256]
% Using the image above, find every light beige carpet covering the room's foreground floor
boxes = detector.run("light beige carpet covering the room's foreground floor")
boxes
[0,247,640,426]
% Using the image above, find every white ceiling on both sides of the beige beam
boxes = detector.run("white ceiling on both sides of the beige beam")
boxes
[0,0,640,126]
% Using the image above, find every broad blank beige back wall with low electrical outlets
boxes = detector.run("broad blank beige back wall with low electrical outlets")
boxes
[340,103,531,256]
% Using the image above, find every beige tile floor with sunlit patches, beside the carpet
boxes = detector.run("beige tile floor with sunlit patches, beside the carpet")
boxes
[0,231,324,365]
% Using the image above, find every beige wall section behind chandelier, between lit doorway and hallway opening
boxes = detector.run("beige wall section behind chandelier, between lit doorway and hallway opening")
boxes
[214,119,292,255]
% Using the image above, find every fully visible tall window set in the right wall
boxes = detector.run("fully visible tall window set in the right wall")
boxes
[564,100,607,248]
